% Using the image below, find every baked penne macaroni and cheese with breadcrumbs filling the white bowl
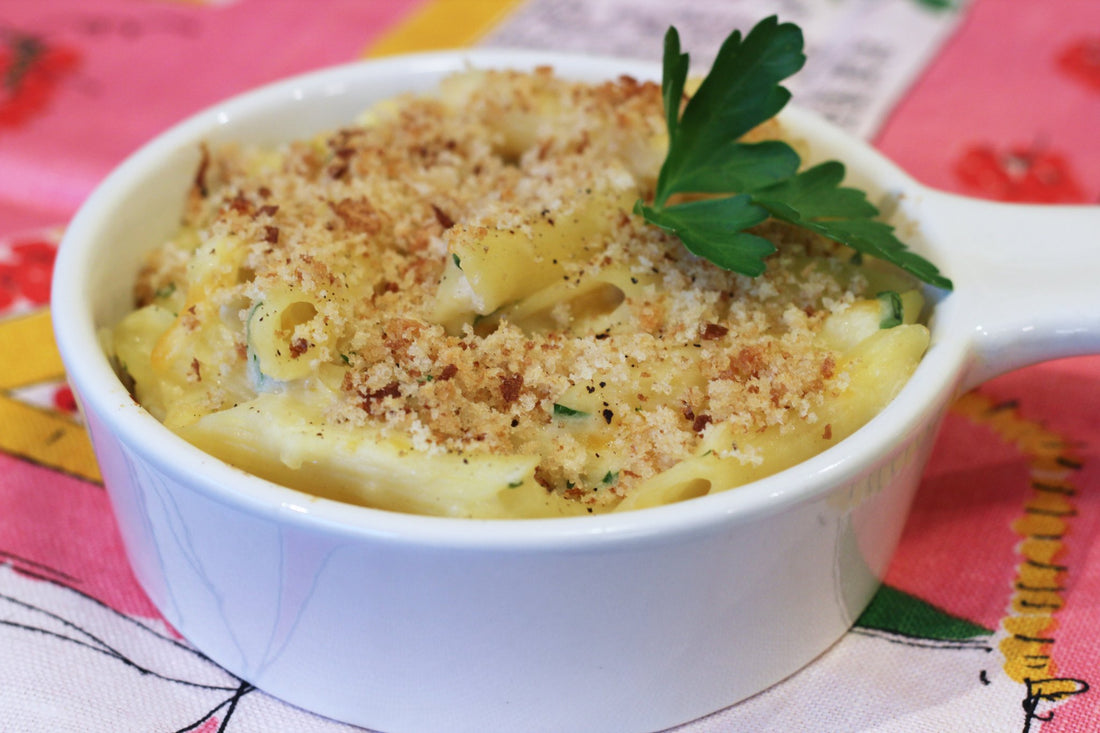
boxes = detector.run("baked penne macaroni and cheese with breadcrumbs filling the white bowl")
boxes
[110,69,928,517]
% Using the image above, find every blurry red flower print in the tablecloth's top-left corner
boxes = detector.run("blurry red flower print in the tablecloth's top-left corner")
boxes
[0,31,80,128]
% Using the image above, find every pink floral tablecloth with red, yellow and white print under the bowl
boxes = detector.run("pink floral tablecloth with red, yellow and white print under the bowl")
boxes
[0,0,1100,733]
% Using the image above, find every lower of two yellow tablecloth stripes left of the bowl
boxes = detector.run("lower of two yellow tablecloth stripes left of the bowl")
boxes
[0,396,102,482]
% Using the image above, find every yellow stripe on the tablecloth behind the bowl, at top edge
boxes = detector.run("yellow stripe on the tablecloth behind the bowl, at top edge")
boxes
[363,0,520,57]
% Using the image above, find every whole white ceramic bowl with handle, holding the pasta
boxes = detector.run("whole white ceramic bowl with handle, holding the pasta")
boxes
[53,51,1100,733]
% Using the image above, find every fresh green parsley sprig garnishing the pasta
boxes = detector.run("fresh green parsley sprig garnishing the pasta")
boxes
[635,17,952,289]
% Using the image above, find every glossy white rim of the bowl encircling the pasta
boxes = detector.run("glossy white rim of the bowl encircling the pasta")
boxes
[51,48,967,550]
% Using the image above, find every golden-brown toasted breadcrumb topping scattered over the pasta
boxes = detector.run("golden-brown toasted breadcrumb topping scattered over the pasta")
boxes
[135,69,867,504]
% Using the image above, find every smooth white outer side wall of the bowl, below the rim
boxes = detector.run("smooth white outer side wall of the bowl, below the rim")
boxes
[92,400,946,731]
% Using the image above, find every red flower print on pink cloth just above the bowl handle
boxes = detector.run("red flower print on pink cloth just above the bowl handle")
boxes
[955,145,1086,204]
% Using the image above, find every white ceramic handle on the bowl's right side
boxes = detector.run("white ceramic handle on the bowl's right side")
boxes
[917,192,1100,390]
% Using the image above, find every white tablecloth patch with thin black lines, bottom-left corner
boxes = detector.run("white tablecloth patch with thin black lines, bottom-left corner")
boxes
[0,549,361,733]
